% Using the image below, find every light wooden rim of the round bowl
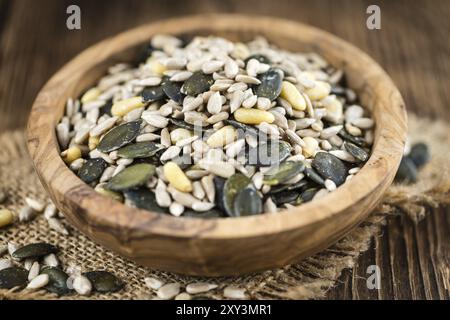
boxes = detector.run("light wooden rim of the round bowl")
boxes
[27,14,406,240]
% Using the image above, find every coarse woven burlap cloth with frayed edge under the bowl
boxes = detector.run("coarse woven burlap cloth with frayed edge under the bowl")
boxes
[0,116,450,299]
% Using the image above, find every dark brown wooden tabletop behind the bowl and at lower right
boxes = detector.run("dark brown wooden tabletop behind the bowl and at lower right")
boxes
[0,0,450,299]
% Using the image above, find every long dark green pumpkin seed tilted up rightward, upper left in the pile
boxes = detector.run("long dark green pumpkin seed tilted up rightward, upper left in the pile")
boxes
[97,119,142,152]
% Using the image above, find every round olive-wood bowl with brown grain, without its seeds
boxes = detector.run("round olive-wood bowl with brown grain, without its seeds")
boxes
[28,15,406,276]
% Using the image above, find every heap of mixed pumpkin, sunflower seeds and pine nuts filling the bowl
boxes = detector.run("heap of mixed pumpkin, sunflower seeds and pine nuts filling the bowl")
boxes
[56,35,374,218]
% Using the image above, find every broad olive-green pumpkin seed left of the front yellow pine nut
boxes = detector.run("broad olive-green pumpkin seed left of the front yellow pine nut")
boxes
[106,163,155,191]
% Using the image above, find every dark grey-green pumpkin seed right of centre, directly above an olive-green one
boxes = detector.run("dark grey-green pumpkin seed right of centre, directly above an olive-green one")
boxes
[247,141,292,167]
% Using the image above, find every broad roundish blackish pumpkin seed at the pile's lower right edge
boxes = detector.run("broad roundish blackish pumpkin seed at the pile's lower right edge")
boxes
[312,152,347,186]
